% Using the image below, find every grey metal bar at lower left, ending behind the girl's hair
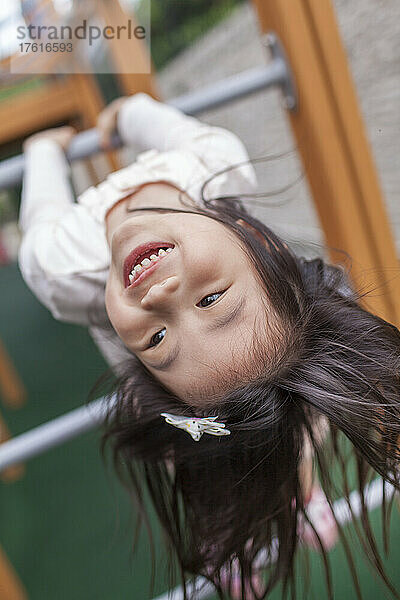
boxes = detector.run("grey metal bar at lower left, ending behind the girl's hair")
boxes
[0,397,115,473]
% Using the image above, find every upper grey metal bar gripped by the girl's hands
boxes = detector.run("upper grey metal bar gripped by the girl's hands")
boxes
[0,57,288,190]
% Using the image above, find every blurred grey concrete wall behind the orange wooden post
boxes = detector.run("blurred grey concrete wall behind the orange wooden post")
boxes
[158,0,400,255]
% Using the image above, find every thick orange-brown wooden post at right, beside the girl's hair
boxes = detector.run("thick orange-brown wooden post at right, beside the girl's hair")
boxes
[253,0,400,326]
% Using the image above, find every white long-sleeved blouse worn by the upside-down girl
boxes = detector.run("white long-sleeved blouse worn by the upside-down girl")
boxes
[19,93,257,366]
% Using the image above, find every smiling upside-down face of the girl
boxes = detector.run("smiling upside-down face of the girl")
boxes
[106,183,265,402]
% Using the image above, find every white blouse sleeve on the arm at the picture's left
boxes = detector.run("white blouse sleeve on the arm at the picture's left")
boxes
[18,139,110,325]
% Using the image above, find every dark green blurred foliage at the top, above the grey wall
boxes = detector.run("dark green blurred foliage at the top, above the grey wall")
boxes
[151,0,244,69]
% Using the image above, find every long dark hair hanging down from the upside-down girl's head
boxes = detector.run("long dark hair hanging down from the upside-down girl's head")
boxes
[97,170,400,600]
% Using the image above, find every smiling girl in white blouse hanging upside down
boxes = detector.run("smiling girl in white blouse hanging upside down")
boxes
[19,94,400,600]
